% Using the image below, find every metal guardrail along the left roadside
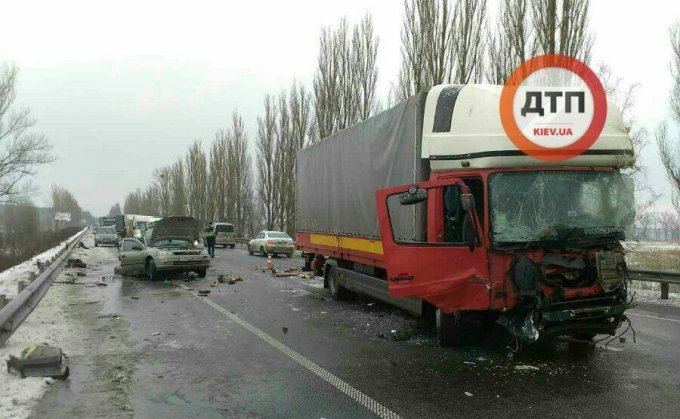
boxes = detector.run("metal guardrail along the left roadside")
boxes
[0,229,87,345]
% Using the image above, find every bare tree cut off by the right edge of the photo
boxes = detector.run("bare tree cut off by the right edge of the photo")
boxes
[656,23,680,212]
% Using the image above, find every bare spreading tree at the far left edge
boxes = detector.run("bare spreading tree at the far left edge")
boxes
[0,66,54,203]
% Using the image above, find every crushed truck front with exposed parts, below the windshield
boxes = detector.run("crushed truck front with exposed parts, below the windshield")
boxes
[498,250,630,342]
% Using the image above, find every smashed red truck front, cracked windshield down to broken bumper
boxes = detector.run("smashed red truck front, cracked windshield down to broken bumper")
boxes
[489,171,634,342]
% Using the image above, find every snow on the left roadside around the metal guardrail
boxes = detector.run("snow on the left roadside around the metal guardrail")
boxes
[0,231,90,418]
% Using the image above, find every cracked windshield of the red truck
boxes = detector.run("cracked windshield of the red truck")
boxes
[489,171,635,244]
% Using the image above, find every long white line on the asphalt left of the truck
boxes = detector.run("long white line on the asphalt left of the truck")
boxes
[200,298,400,419]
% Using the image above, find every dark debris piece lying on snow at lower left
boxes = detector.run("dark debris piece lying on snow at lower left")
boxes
[5,343,69,379]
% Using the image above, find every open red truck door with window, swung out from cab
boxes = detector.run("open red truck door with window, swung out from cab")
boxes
[376,178,490,313]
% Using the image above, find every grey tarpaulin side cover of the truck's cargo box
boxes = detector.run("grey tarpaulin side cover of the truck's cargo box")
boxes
[296,92,429,239]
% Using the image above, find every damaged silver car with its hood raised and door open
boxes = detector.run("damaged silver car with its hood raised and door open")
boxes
[119,217,210,281]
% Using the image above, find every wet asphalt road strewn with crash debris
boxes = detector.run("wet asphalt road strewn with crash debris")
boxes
[34,238,680,418]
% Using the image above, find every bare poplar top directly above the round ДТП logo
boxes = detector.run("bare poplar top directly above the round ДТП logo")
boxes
[531,0,593,64]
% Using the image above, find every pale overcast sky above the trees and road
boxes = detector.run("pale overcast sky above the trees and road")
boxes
[0,0,680,215]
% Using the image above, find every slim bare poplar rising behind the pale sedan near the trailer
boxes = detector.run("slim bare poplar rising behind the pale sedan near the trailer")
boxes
[256,95,278,230]
